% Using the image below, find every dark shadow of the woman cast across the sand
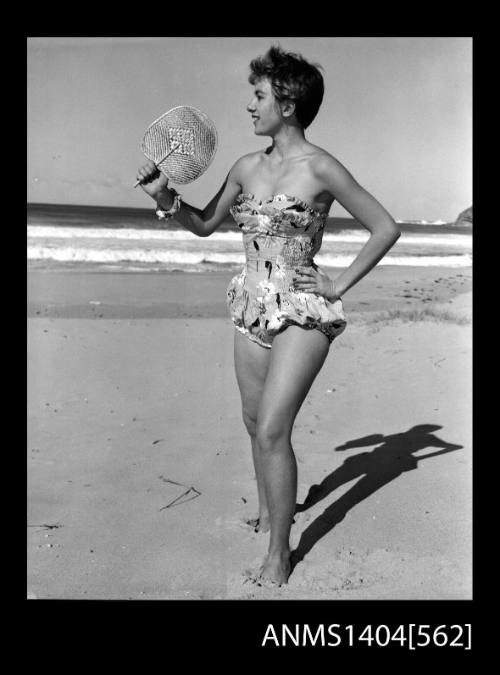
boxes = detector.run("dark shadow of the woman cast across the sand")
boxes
[292,424,463,568]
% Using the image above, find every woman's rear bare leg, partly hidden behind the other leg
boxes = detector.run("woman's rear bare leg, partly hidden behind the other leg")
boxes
[234,330,271,532]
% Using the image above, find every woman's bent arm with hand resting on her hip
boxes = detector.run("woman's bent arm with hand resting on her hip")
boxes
[308,155,401,300]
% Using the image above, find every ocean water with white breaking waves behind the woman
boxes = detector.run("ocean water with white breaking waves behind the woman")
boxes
[27,204,472,273]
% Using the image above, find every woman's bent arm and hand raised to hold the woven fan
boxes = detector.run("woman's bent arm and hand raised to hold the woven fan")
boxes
[137,158,243,237]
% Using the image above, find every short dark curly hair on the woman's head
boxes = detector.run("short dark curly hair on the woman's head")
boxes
[248,46,325,129]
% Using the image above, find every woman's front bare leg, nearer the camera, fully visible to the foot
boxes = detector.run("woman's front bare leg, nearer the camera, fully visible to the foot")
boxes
[256,326,330,584]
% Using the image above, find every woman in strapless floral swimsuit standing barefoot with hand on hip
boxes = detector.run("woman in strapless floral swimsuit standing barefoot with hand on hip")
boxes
[137,47,400,585]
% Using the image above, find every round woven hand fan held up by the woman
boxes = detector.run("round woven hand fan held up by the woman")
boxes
[136,105,217,185]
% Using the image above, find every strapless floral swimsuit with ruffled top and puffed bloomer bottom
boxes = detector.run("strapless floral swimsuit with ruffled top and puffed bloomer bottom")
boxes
[226,193,346,348]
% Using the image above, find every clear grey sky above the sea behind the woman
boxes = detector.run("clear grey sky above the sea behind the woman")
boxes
[27,37,472,221]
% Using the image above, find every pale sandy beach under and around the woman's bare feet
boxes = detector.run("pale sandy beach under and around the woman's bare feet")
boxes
[27,266,472,600]
